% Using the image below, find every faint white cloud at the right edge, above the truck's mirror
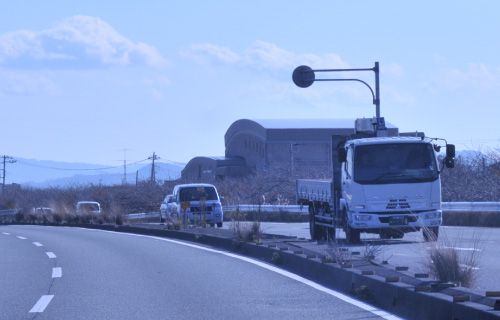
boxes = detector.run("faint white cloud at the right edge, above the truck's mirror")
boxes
[426,63,500,91]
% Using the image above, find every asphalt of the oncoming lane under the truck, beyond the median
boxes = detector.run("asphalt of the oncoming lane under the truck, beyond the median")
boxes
[238,222,500,294]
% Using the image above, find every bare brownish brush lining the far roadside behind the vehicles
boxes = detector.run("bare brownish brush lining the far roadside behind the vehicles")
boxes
[0,149,500,226]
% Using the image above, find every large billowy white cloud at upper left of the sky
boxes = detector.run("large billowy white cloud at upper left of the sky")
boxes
[0,15,165,68]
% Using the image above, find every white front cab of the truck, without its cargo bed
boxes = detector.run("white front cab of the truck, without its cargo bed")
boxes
[339,137,450,242]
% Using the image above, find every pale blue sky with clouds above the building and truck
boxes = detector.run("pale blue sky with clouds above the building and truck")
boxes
[0,0,500,166]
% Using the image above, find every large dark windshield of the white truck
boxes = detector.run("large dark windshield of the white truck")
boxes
[354,143,438,184]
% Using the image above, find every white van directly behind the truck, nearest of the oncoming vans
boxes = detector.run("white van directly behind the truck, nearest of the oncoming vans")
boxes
[170,183,224,228]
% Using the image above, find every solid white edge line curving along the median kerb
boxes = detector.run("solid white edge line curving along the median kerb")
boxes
[88,228,402,320]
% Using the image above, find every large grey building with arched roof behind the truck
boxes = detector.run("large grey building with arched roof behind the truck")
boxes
[182,119,398,182]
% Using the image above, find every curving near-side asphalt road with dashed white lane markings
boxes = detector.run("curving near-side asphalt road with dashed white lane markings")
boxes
[0,226,396,319]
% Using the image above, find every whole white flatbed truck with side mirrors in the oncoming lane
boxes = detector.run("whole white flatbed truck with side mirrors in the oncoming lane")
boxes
[297,118,455,243]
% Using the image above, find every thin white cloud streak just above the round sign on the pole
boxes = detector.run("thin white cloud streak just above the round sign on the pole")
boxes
[181,41,349,70]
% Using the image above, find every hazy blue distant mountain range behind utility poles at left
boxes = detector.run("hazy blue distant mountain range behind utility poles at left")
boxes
[4,157,186,188]
